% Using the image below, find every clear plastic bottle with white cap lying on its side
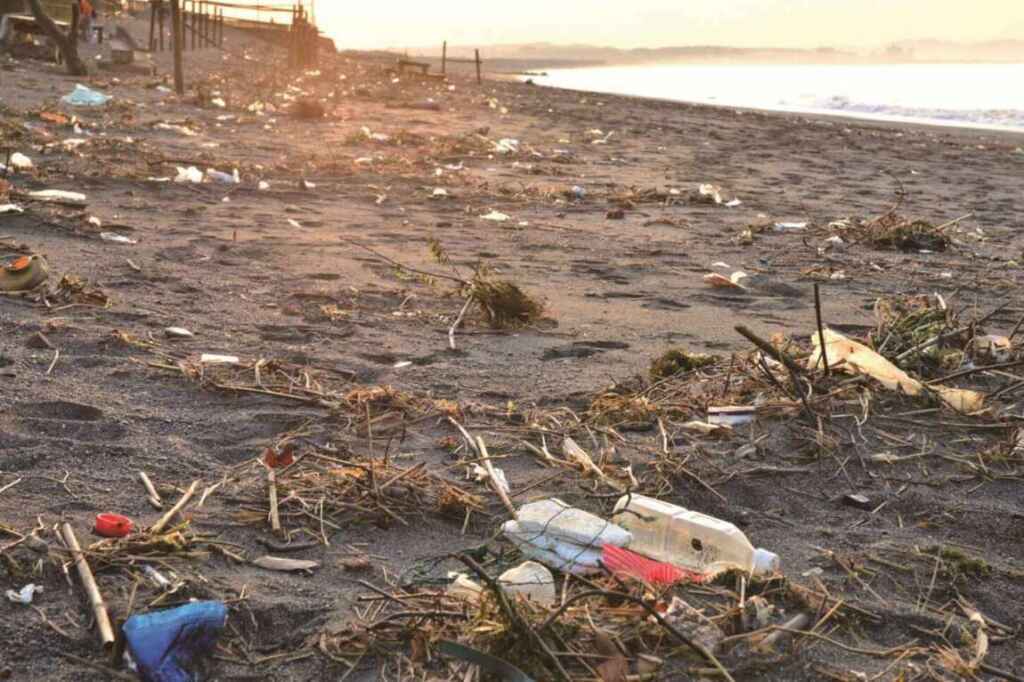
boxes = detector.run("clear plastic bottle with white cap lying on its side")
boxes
[613,495,779,578]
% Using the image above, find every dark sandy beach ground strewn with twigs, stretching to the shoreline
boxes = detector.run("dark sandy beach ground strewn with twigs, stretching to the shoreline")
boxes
[0,11,1024,682]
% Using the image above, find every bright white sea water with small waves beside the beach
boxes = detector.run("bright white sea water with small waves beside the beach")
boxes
[534,63,1024,132]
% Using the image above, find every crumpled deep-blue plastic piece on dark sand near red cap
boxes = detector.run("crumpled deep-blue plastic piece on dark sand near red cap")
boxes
[123,601,227,682]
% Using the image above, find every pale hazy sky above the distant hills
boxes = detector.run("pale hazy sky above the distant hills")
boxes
[306,0,1024,48]
